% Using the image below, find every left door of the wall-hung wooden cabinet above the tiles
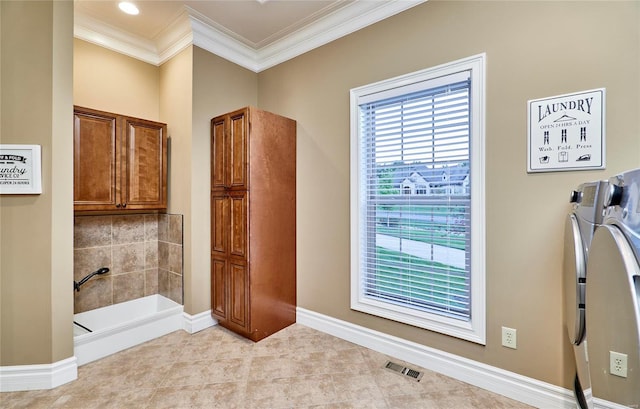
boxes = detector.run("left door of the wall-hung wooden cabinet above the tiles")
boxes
[73,110,120,210]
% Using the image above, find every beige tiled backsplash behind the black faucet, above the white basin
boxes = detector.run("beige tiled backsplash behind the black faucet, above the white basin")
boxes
[76,214,183,313]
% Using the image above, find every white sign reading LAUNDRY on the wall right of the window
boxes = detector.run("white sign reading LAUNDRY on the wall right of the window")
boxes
[527,88,605,172]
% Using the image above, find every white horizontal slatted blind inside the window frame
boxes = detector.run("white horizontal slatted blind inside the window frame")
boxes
[360,75,471,320]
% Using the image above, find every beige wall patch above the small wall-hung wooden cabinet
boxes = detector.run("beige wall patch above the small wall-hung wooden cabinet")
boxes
[73,39,162,122]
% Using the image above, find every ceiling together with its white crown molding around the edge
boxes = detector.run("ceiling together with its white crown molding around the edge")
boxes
[74,0,426,72]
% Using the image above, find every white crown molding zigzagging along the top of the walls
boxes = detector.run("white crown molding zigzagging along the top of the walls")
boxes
[74,0,427,72]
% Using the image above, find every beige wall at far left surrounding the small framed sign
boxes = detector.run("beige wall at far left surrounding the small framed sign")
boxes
[0,1,73,366]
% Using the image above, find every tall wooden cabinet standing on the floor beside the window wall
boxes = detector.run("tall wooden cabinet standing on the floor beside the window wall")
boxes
[211,107,296,341]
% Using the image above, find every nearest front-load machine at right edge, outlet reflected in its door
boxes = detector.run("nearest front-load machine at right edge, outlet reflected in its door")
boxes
[585,169,640,408]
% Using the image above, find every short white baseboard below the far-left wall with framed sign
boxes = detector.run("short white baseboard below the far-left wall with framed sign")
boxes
[0,356,78,392]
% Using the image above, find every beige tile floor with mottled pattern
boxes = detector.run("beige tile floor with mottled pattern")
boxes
[0,324,529,409]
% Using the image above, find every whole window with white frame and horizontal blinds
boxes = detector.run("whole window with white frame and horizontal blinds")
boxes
[351,54,485,344]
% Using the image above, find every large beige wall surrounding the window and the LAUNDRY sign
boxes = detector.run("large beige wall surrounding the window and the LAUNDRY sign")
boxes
[258,1,640,387]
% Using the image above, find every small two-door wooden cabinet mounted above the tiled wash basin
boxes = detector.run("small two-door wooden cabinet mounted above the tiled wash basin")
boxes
[73,106,167,212]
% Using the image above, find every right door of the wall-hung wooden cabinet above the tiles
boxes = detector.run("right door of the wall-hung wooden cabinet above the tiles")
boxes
[121,118,167,210]
